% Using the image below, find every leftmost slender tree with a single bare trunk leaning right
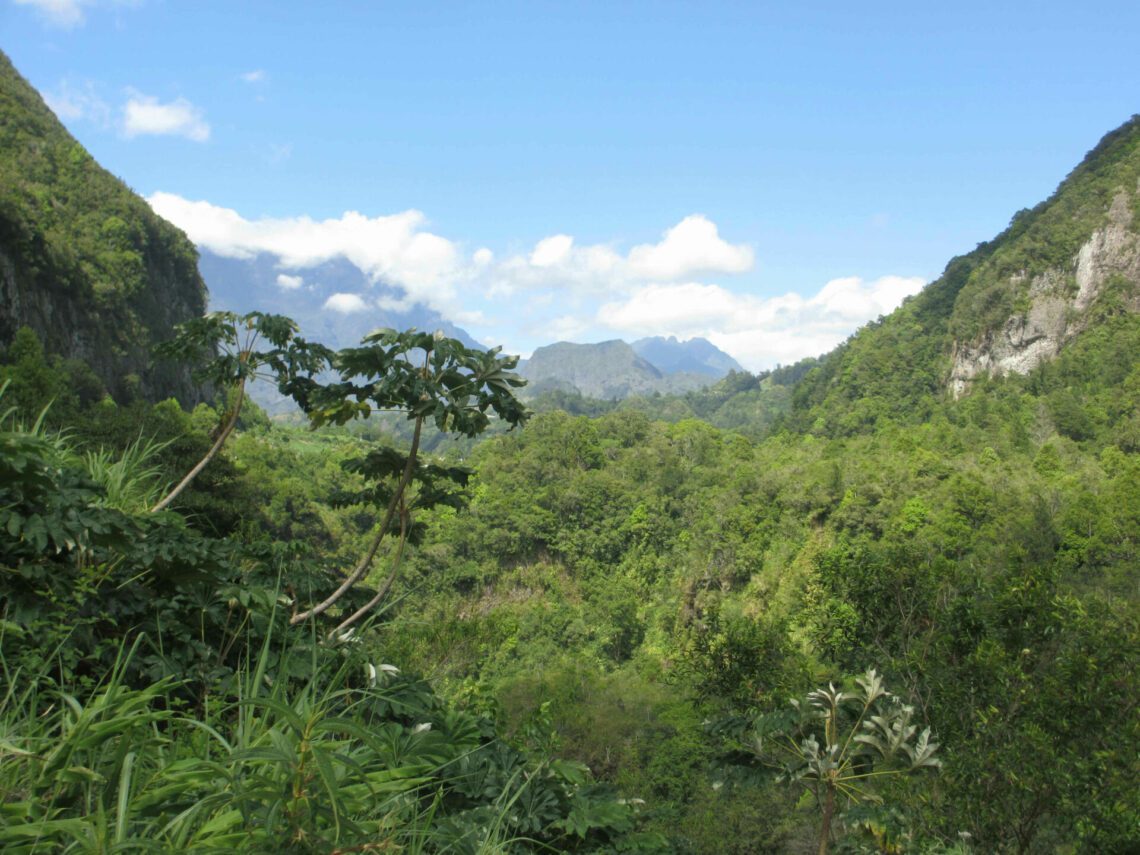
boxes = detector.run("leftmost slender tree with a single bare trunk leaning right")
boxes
[150,311,332,513]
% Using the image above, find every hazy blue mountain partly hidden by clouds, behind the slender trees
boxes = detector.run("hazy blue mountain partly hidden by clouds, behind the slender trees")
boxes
[198,249,483,348]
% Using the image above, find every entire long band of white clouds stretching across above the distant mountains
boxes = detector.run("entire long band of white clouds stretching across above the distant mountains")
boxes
[149,193,923,371]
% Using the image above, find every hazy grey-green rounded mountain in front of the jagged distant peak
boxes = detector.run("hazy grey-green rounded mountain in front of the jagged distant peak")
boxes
[519,340,714,400]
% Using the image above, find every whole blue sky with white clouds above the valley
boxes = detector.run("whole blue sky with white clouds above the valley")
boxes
[0,0,1140,371]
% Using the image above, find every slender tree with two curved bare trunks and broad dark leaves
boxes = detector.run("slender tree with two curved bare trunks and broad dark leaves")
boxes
[289,329,530,632]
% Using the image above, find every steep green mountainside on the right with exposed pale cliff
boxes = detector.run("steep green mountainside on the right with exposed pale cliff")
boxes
[785,116,1140,435]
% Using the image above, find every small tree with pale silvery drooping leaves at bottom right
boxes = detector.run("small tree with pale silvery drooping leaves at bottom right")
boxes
[748,668,942,855]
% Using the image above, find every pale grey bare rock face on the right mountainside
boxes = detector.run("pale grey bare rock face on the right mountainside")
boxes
[948,187,1140,398]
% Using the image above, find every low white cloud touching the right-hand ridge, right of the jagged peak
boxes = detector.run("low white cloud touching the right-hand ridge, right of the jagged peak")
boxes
[597,276,925,368]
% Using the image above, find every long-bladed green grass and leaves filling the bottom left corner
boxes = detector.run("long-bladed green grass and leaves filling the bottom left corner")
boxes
[0,635,554,855]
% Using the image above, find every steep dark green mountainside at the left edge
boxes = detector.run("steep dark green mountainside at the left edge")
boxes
[0,54,206,405]
